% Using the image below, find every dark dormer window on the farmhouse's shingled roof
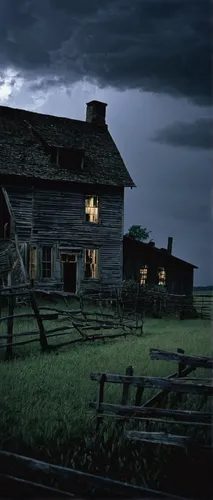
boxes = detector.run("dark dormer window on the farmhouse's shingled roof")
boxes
[51,147,84,170]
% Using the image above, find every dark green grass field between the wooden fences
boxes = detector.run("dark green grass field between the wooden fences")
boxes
[0,300,212,496]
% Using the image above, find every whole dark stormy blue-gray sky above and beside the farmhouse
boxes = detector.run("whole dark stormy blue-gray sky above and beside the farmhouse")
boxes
[0,0,213,285]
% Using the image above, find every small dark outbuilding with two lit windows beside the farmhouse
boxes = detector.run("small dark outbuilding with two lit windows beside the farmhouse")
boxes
[123,236,197,295]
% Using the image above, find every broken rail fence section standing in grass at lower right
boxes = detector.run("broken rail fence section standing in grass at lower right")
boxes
[90,349,213,448]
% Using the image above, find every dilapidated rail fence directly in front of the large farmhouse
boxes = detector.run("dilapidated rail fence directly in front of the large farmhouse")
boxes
[0,284,143,360]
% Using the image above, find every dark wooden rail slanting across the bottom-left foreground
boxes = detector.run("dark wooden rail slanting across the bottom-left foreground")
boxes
[0,451,192,500]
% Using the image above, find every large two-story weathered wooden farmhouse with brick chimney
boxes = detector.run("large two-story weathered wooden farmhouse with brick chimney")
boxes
[0,101,135,293]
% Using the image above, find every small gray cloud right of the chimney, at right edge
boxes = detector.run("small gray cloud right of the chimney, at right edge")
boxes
[152,118,213,149]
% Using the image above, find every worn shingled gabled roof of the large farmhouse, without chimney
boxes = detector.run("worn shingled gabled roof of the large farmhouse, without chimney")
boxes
[0,106,135,187]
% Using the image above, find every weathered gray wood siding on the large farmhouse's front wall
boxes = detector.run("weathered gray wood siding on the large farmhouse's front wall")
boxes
[6,185,124,290]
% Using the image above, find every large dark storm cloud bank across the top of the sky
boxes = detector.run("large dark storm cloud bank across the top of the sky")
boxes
[0,0,211,105]
